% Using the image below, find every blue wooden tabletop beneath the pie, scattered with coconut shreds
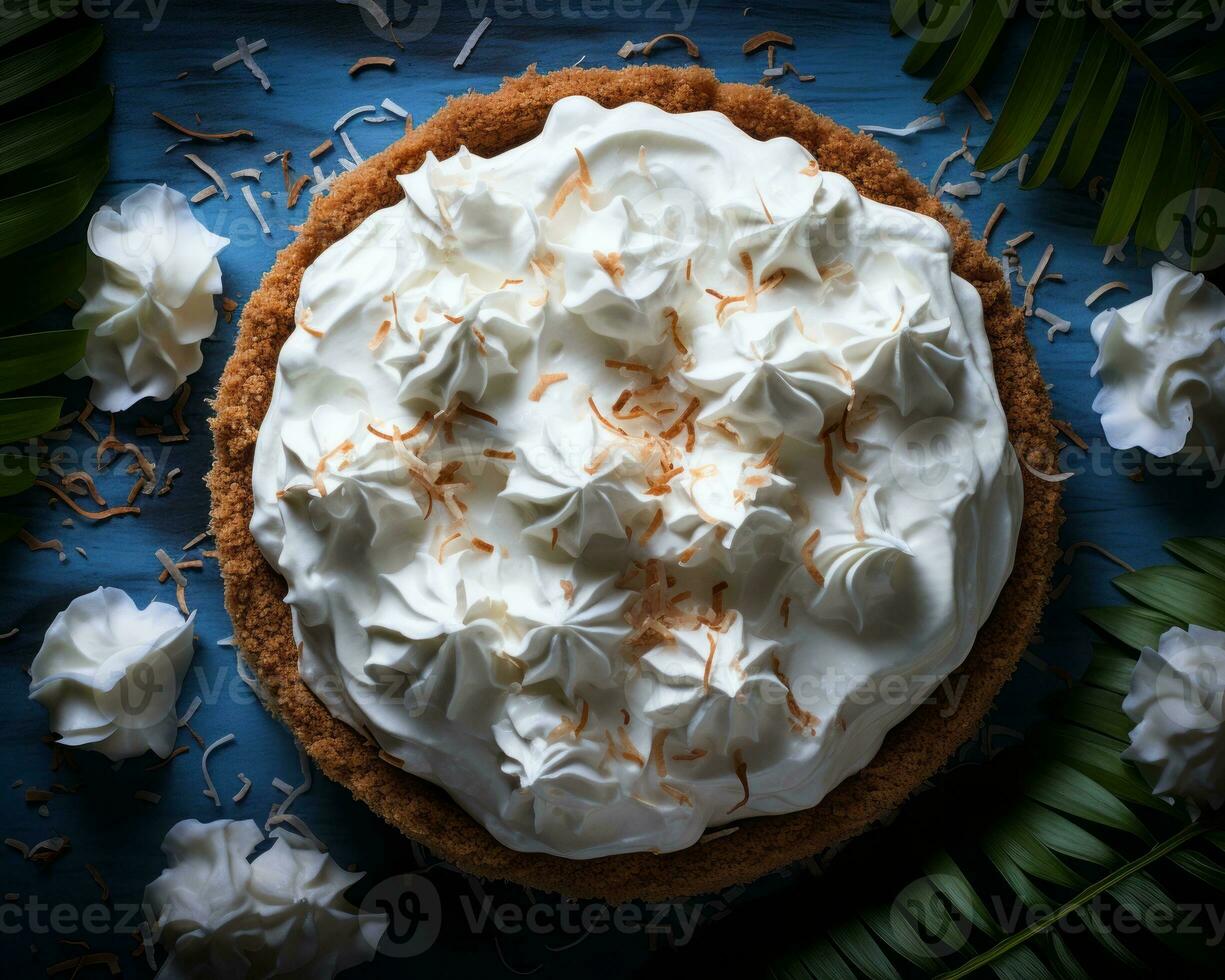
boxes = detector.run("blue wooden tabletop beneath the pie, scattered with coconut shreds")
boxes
[0,0,1225,978]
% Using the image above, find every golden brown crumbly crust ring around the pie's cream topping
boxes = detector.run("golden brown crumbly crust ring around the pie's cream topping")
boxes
[208,66,1062,902]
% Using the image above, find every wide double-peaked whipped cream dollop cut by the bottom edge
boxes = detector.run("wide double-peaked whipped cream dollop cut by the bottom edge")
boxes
[143,820,387,980]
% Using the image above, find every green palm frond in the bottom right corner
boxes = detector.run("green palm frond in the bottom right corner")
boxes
[657,538,1225,980]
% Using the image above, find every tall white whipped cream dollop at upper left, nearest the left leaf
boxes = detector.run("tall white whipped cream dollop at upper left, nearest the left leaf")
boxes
[69,184,229,412]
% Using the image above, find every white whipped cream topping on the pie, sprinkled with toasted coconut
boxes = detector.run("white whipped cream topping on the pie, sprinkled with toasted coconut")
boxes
[251,98,1020,858]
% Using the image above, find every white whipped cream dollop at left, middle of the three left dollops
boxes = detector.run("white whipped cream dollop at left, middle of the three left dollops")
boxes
[29,588,196,761]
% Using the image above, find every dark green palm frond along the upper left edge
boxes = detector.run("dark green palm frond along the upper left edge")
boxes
[0,0,114,541]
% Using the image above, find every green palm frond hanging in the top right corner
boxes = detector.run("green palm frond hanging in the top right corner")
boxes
[891,0,1225,259]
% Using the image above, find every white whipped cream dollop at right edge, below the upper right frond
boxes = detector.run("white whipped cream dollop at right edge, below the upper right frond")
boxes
[1090,262,1225,456]
